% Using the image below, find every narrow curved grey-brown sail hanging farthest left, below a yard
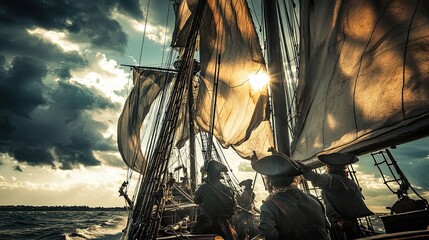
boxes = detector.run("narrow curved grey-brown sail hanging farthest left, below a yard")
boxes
[118,68,176,173]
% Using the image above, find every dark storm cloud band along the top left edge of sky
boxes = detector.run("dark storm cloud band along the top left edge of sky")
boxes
[0,0,142,51]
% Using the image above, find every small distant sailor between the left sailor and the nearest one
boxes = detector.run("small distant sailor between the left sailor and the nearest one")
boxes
[234,179,257,240]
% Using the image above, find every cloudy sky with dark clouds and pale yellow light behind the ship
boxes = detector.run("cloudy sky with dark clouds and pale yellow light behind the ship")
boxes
[0,0,429,211]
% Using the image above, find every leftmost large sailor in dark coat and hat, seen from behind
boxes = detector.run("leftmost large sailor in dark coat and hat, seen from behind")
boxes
[192,160,237,239]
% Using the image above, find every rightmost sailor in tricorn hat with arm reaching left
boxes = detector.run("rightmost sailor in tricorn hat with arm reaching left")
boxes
[300,153,374,240]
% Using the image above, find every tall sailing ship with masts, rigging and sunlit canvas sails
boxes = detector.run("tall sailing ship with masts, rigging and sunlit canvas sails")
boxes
[118,0,429,239]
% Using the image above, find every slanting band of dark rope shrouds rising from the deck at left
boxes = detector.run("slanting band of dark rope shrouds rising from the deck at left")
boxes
[129,1,205,239]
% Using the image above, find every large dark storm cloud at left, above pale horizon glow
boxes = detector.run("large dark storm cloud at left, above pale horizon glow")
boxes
[0,58,119,169]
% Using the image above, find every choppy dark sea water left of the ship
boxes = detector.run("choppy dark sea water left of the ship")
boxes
[0,211,128,240]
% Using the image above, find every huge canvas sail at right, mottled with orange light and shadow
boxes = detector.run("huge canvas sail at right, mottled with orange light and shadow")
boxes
[292,0,429,160]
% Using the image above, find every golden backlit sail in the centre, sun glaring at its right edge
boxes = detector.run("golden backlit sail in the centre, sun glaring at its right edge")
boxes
[173,0,273,158]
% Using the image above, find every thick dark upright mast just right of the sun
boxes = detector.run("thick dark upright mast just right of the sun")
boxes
[263,0,290,156]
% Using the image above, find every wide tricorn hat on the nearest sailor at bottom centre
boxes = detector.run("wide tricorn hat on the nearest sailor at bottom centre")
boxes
[252,152,302,176]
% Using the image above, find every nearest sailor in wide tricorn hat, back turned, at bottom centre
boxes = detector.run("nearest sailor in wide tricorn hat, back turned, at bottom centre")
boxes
[252,152,329,240]
